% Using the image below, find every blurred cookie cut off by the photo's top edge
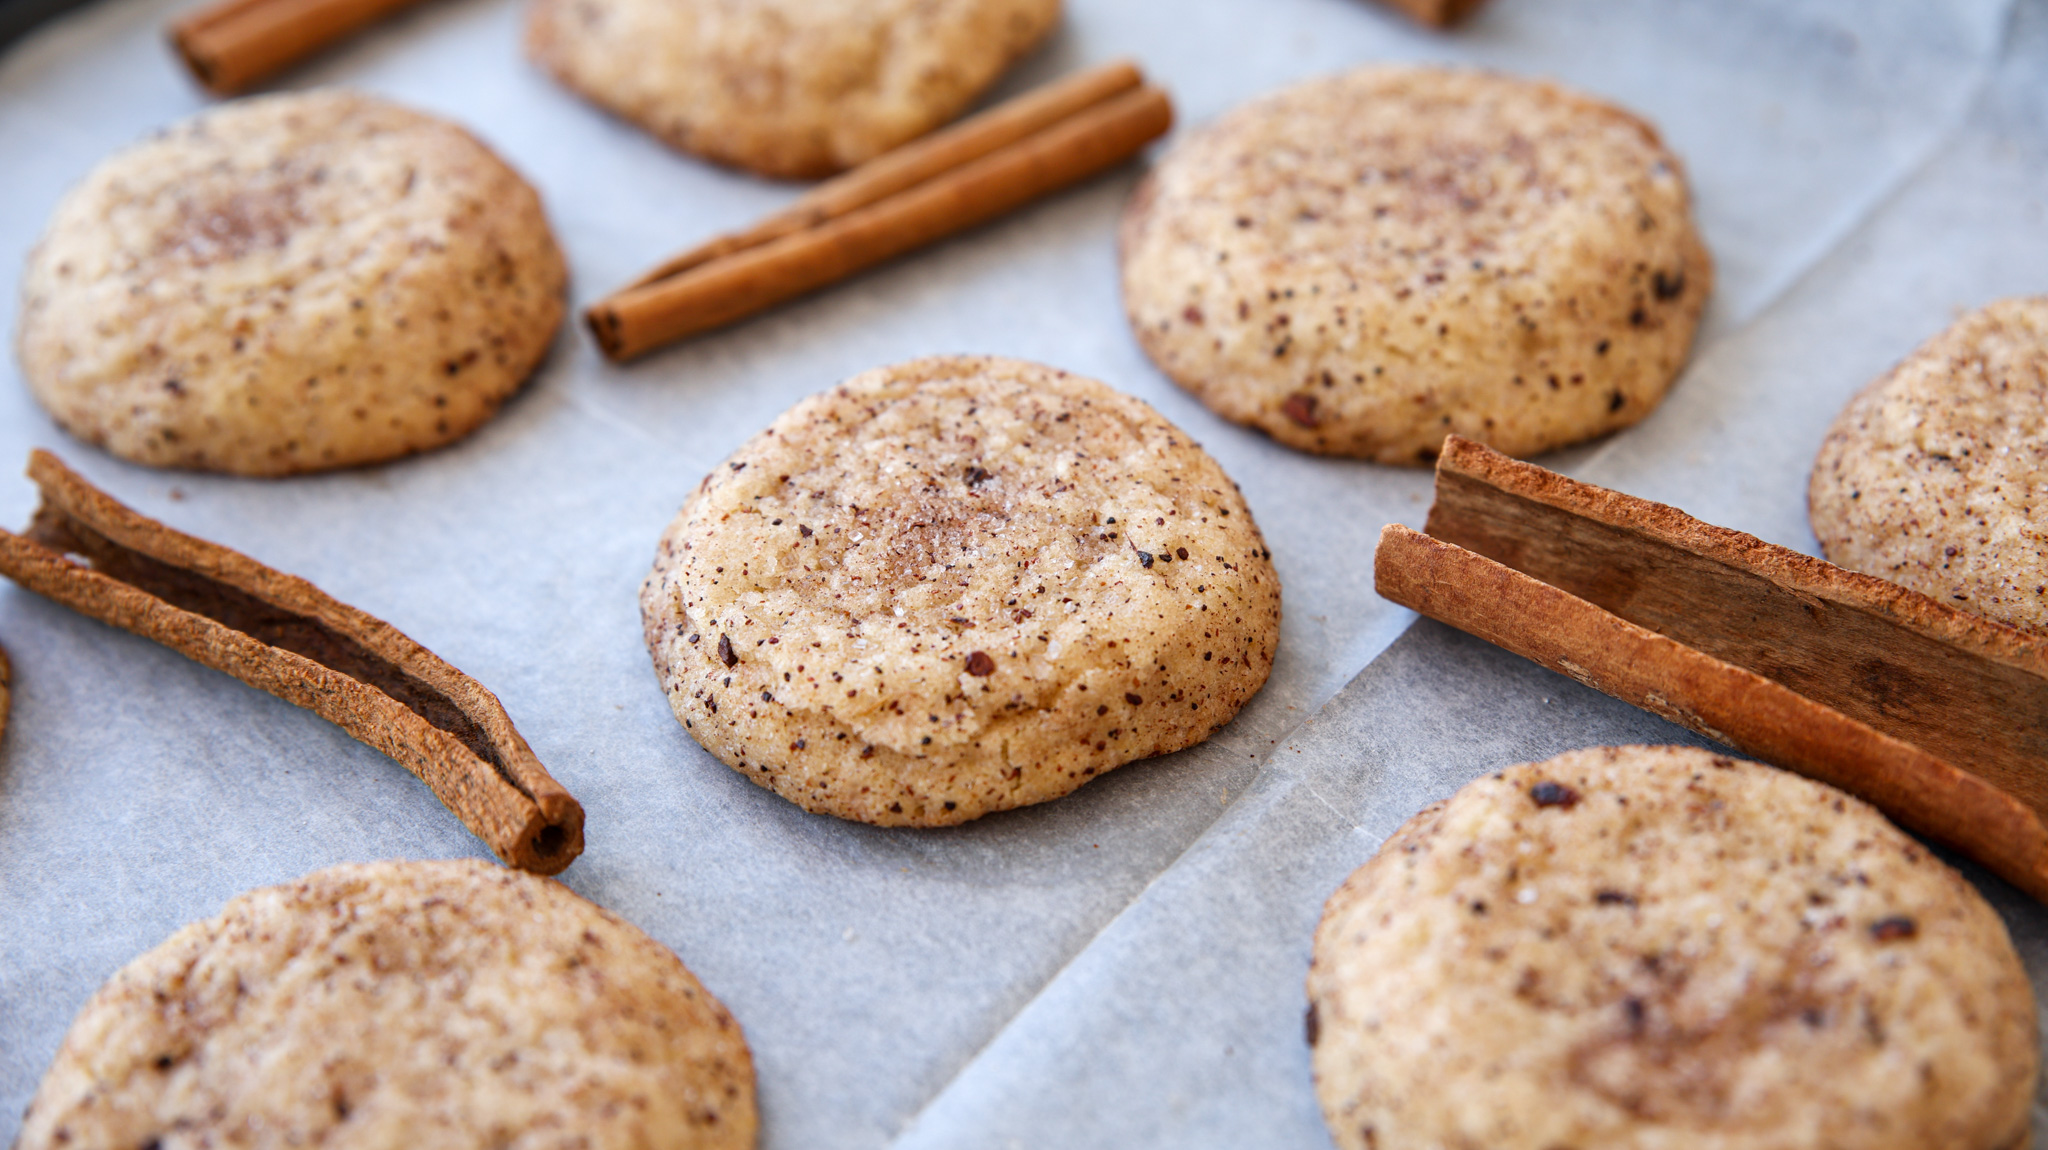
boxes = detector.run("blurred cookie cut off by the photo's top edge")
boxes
[526,0,1059,178]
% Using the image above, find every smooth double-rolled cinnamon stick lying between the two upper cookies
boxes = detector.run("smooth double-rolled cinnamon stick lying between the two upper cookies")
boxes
[584,74,1174,360]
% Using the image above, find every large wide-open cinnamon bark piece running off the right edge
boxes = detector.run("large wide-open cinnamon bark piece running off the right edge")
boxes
[1374,436,2048,902]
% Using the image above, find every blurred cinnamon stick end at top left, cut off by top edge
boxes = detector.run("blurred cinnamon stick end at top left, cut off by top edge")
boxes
[170,0,432,96]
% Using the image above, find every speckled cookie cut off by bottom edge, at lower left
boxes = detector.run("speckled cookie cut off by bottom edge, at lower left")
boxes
[16,859,756,1150]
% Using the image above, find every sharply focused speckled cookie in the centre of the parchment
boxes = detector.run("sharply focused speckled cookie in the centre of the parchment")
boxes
[641,356,1280,827]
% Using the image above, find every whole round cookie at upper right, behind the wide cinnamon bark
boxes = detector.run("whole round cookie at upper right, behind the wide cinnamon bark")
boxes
[1122,68,1714,462]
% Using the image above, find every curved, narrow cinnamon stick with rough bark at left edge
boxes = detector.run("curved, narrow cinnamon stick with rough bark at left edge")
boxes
[0,450,584,874]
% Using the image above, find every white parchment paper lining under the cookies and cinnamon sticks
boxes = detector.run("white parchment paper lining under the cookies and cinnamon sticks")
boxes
[0,0,2048,1148]
